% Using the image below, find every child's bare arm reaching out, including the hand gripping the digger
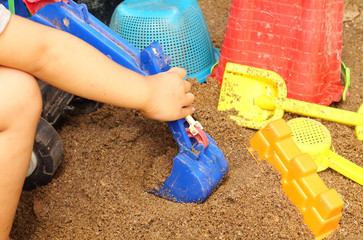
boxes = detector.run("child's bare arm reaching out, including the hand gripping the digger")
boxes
[0,15,194,121]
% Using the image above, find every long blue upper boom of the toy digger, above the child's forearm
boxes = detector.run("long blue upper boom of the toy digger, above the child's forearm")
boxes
[30,0,148,75]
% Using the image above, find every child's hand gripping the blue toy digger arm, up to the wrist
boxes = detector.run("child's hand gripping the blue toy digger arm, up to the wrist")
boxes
[140,68,194,121]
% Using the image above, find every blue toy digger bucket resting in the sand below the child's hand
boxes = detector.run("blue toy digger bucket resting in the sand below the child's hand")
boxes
[151,119,228,203]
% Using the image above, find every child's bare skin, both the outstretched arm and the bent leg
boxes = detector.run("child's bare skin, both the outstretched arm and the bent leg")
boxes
[0,15,194,240]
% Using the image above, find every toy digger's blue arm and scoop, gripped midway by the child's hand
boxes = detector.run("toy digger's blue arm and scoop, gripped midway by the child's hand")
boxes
[30,0,228,203]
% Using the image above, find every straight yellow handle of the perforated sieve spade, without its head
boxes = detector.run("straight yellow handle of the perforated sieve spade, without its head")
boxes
[327,151,363,186]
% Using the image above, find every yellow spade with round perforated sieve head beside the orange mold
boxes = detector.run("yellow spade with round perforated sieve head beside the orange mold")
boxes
[287,118,363,185]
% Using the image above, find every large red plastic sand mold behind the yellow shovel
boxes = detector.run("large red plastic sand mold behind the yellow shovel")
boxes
[215,0,344,105]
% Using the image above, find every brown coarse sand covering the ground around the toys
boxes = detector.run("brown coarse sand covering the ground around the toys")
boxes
[11,0,363,240]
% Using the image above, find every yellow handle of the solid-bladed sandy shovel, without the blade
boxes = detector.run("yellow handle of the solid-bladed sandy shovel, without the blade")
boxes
[257,95,363,126]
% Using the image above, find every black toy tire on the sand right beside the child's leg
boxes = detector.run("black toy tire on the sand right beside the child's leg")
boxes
[23,118,64,190]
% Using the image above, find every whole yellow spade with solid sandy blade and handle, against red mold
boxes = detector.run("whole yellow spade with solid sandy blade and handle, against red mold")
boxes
[218,63,363,140]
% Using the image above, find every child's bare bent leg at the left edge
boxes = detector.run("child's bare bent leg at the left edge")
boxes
[0,66,42,240]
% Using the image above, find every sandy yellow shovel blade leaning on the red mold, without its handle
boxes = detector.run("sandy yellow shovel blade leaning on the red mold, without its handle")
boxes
[218,63,287,129]
